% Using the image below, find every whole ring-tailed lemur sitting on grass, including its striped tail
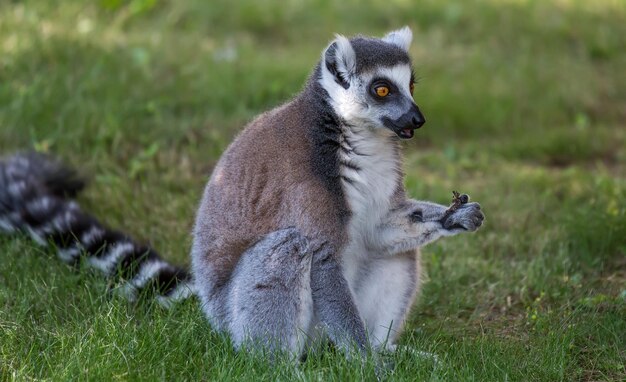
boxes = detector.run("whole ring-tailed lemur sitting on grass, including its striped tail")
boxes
[0,27,484,354]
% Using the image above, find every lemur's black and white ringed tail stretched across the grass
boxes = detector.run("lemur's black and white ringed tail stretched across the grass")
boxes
[0,153,194,306]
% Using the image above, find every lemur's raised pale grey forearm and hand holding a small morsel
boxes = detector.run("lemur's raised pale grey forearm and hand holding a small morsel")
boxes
[370,199,484,256]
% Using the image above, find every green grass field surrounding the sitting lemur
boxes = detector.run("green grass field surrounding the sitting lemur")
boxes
[0,0,626,381]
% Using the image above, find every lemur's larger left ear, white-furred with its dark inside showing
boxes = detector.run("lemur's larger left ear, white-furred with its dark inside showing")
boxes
[322,35,356,89]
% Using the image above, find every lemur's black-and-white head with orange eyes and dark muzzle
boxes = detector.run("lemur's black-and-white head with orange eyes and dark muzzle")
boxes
[319,27,425,139]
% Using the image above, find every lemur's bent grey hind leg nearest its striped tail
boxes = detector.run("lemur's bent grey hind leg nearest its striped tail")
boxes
[227,228,313,356]
